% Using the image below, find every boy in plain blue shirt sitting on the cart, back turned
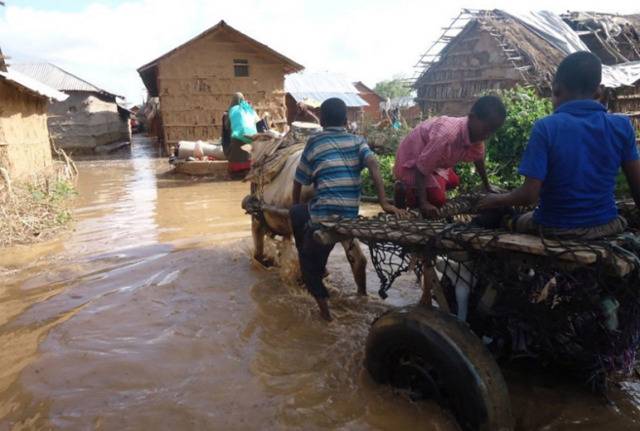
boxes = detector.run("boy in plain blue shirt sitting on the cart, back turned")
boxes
[478,51,640,239]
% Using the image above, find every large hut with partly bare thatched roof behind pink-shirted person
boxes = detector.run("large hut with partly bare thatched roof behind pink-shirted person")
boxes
[414,10,579,115]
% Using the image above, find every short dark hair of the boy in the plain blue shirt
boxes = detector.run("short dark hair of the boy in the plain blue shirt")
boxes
[553,51,602,96]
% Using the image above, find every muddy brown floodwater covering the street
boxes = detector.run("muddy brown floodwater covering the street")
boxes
[0,138,640,431]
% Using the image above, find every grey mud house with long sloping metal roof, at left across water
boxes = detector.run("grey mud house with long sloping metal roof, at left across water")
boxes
[11,63,131,154]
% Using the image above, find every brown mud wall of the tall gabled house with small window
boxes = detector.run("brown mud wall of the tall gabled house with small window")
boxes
[158,31,287,145]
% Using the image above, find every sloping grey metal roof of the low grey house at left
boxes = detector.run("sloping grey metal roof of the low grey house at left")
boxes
[11,63,117,96]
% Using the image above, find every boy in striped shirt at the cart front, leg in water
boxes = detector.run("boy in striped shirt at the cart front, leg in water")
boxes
[289,98,403,320]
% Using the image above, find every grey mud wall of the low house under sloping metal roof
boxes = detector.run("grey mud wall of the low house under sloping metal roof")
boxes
[49,91,130,153]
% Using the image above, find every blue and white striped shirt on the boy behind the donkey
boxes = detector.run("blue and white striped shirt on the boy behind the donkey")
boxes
[295,127,374,223]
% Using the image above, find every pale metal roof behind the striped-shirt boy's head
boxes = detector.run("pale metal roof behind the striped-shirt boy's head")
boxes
[284,72,369,107]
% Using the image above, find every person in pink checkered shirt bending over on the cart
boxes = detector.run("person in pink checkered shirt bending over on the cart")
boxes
[393,96,506,217]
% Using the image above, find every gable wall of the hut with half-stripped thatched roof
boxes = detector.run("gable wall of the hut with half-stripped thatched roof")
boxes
[417,25,524,115]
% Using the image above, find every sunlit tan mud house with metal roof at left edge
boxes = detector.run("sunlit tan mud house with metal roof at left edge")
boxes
[0,51,68,180]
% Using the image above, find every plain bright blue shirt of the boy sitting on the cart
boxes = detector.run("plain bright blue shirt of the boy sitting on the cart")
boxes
[519,100,638,229]
